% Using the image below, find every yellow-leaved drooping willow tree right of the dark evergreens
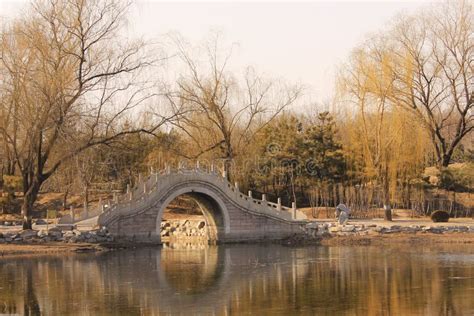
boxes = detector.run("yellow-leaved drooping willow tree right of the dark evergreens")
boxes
[341,39,426,220]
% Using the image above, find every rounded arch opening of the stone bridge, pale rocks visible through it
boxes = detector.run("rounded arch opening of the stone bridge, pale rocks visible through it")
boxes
[157,188,229,244]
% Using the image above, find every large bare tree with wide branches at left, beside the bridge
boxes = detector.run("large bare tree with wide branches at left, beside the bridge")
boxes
[0,0,170,228]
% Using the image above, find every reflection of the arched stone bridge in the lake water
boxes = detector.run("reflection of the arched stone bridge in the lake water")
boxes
[96,245,308,315]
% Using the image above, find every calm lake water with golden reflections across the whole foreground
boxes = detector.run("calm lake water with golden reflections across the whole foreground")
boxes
[0,245,474,315]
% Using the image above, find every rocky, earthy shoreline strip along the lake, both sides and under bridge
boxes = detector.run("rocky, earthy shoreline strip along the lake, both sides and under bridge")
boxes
[0,219,474,260]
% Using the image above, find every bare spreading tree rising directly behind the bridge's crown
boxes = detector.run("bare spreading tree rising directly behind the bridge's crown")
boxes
[167,36,301,178]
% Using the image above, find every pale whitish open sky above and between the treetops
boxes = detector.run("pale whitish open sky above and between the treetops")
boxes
[0,0,436,106]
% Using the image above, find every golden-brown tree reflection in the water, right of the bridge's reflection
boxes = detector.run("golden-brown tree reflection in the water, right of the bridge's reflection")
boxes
[223,247,474,315]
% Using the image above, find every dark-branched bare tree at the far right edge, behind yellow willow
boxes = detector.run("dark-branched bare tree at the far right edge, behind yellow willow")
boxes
[391,1,474,168]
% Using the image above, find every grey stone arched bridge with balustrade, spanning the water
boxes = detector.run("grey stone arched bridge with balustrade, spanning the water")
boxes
[99,166,308,243]
